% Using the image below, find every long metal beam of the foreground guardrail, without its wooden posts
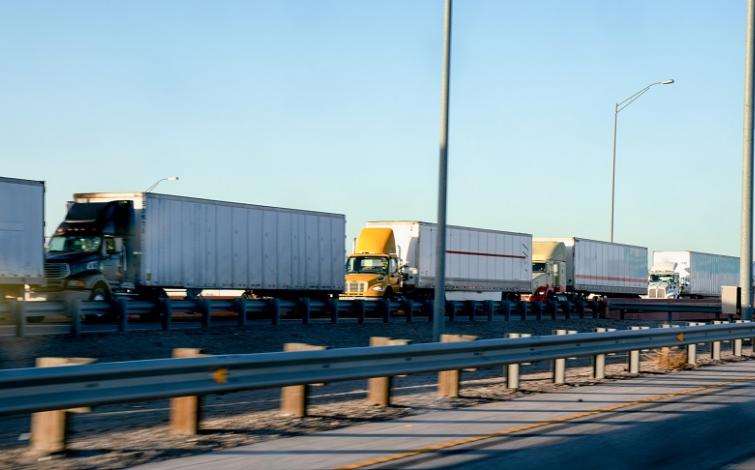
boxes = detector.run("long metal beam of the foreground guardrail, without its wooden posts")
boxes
[0,322,755,414]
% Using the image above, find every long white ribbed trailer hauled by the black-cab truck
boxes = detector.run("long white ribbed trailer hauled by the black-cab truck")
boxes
[58,193,345,295]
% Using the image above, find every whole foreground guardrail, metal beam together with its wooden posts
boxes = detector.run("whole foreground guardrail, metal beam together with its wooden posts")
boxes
[0,321,755,458]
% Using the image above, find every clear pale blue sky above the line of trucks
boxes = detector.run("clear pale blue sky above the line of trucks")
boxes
[0,0,745,255]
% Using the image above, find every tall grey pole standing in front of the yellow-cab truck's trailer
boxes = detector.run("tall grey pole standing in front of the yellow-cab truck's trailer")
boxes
[433,0,452,341]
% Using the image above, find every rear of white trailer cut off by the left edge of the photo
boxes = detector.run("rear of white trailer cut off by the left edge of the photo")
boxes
[0,177,45,299]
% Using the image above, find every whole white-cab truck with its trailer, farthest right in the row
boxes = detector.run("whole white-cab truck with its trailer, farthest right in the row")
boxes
[648,251,739,299]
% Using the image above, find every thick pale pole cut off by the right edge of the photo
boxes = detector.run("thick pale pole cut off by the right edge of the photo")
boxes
[739,0,755,320]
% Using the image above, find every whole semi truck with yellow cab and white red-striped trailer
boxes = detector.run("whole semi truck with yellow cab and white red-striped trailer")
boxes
[341,221,532,300]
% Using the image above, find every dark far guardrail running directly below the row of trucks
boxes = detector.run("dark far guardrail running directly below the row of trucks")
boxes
[0,298,600,337]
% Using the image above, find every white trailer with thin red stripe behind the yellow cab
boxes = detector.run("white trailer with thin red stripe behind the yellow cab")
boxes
[366,221,532,299]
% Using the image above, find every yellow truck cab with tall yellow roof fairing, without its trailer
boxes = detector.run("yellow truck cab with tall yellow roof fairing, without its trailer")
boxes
[341,227,402,299]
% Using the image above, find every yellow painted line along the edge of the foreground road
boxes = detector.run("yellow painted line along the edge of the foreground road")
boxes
[335,375,755,470]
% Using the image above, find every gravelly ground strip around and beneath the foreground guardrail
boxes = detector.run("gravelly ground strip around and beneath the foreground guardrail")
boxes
[0,319,744,469]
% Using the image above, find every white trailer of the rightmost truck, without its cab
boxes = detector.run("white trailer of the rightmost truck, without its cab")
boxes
[652,251,739,297]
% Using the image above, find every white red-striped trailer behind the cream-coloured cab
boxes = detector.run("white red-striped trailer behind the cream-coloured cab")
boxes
[535,237,648,295]
